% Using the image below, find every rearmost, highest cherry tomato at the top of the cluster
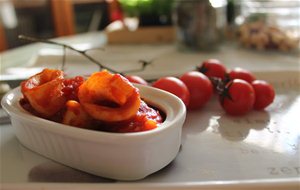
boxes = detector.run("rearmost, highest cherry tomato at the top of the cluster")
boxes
[197,59,226,79]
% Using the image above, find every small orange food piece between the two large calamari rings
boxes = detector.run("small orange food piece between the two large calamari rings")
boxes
[62,100,91,128]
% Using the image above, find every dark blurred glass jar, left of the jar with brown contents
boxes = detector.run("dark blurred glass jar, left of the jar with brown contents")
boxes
[173,0,227,50]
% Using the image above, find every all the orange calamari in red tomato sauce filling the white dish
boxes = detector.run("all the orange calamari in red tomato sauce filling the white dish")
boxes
[20,69,164,133]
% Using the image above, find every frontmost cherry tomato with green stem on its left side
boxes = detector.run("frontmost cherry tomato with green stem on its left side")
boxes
[220,79,255,116]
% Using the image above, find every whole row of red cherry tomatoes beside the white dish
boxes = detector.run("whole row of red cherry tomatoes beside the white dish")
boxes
[126,59,275,116]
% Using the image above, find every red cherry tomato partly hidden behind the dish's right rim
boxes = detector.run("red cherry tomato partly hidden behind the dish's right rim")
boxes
[152,77,190,106]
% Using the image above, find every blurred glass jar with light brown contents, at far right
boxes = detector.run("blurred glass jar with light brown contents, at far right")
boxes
[236,0,300,51]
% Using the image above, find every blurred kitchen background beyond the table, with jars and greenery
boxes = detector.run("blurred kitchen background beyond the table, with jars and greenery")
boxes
[0,0,300,51]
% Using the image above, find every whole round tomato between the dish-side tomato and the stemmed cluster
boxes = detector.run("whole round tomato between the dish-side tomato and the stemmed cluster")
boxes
[180,71,213,109]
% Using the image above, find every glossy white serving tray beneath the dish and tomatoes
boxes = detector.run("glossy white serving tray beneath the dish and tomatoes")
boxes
[0,45,300,189]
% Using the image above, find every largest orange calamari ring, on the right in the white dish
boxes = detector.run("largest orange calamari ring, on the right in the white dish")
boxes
[78,71,141,122]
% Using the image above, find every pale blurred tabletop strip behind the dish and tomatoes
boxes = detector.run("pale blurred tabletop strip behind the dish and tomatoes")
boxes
[0,44,300,81]
